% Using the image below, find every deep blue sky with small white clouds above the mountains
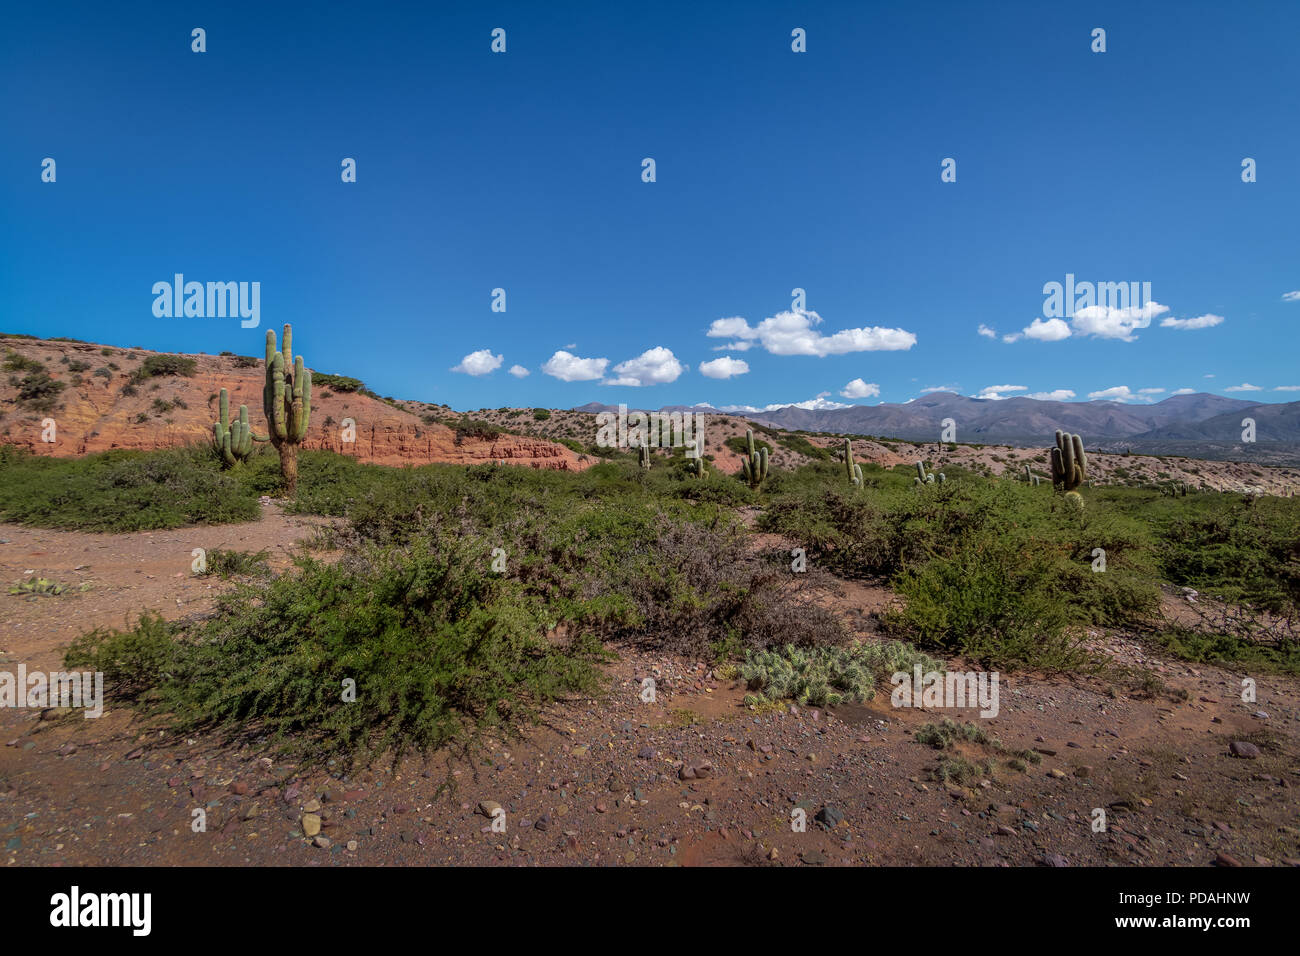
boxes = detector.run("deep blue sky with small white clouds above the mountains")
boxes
[0,0,1300,408]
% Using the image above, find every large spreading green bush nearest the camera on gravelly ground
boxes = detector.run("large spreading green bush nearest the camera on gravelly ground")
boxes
[66,541,601,763]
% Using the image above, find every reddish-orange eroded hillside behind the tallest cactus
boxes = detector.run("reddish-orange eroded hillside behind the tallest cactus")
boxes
[0,336,592,471]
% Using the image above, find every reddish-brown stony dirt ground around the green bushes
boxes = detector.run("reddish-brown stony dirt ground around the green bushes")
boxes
[0,515,1300,866]
